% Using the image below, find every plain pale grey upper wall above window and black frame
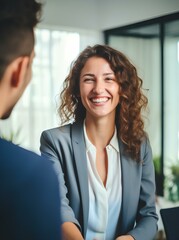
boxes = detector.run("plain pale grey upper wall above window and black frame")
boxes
[42,0,179,31]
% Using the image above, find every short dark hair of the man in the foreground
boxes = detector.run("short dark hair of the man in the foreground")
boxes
[0,0,41,79]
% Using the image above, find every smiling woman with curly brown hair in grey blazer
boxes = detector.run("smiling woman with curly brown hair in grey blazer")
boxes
[40,45,158,240]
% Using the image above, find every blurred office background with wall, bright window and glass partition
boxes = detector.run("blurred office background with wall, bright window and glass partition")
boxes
[0,0,179,201]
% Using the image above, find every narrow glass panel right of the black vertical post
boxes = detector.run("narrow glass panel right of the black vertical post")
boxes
[164,20,179,201]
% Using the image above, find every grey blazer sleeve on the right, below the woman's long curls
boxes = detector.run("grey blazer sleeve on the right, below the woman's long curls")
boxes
[129,138,158,240]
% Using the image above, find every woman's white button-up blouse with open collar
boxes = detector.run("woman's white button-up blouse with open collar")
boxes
[84,124,122,240]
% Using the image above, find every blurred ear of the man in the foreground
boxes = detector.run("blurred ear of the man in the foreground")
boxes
[11,56,29,87]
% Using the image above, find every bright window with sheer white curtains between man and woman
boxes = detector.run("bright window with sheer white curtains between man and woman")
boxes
[0,29,80,152]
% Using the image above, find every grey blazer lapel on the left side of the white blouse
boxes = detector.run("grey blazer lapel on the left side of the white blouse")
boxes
[72,123,89,235]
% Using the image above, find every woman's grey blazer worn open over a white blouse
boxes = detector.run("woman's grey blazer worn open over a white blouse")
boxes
[40,123,158,240]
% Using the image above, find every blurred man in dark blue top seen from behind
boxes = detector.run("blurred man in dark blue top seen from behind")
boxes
[0,0,60,240]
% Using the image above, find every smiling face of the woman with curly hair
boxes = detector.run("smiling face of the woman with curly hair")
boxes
[80,57,119,119]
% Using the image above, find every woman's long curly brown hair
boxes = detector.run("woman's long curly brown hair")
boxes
[58,45,148,161]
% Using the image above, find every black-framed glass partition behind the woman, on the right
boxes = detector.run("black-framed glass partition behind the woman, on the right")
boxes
[104,12,179,198]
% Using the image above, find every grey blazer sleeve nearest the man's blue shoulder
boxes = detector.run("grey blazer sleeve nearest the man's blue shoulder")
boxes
[40,128,81,229]
